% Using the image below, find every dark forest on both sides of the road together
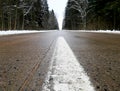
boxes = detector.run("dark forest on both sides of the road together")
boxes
[0,0,120,30]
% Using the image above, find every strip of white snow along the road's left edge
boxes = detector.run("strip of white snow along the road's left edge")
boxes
[0,30,56,36]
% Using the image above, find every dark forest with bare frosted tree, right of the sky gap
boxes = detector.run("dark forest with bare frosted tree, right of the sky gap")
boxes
[63,0,120,30]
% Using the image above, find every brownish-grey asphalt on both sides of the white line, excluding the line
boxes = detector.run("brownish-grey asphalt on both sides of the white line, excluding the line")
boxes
[0,31,120,91]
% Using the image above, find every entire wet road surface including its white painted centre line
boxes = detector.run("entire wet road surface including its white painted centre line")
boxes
[0,31,120,91]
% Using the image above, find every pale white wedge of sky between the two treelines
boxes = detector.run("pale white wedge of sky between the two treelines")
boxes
[48,0,68,29]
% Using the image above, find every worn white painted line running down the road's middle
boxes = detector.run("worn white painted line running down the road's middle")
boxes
[42,37,95,91]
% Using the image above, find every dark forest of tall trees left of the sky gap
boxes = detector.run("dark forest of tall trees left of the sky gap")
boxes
[0,0,58,30]
